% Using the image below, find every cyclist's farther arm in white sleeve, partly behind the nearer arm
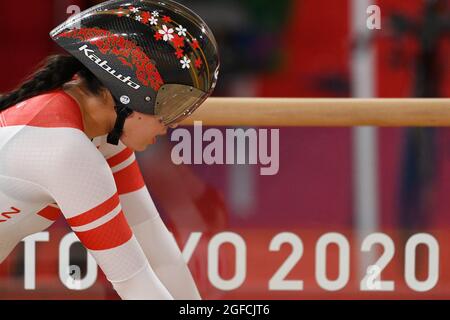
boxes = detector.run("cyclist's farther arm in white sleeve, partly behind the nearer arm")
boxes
[103,141,201,300]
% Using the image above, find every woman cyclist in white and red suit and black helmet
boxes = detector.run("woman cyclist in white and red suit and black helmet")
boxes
[0,0,219,299]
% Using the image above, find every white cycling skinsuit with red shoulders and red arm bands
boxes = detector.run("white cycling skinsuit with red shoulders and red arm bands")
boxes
[0,90,200,299]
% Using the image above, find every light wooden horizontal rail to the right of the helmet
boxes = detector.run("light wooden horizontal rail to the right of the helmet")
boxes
[181,98,450,127]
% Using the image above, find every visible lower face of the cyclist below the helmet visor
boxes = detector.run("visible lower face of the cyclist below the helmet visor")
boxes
[120,112,167,151]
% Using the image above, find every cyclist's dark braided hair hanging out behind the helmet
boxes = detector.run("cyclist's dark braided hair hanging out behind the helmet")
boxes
[0,55,104,112]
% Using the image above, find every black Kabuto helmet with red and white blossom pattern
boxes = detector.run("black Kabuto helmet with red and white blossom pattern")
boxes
[50,0,220,144]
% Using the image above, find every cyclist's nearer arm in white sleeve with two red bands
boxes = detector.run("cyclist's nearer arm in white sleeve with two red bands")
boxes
[27,131,172,299]
